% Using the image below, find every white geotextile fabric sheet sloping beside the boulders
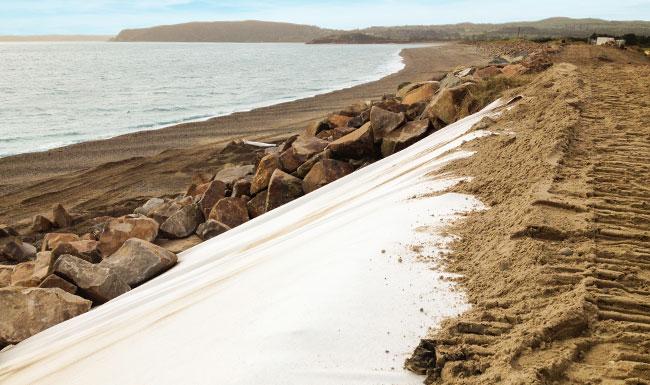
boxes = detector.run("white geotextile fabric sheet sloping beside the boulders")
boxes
[0,102,499,385]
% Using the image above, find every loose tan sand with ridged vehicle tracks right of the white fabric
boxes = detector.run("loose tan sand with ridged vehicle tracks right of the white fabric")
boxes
[407,45,650,385]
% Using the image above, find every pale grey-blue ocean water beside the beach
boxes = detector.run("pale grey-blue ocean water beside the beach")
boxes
[0,42,418,157]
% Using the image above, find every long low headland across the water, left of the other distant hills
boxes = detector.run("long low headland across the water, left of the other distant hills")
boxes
[112,20,337,43]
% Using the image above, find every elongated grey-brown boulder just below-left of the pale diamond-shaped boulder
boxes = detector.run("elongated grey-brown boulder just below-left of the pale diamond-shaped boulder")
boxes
[54,255,131,304]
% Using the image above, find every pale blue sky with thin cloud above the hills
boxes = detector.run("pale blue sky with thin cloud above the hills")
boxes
[0,0,650,35]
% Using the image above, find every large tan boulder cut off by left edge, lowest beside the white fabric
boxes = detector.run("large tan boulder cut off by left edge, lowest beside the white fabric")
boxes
[0,287,91,346]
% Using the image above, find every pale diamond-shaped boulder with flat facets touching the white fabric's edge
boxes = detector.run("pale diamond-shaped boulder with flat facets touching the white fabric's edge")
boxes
[99,238,177,287]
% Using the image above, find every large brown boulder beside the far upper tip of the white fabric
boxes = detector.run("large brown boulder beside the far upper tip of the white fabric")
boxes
[423,84,475,124]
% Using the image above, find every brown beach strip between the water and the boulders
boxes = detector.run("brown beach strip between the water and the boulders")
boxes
[0,44,487,225]
